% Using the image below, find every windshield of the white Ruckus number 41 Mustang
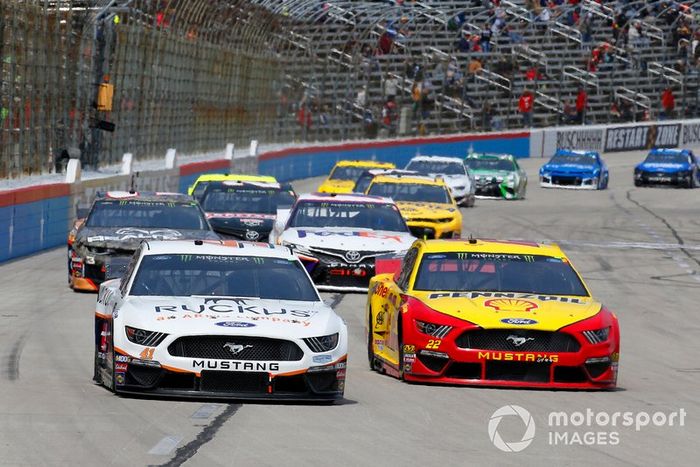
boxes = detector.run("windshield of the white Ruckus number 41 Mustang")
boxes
[130,254,318,302]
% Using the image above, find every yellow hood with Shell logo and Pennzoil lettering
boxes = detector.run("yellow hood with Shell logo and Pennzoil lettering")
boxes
[413,292,601,331]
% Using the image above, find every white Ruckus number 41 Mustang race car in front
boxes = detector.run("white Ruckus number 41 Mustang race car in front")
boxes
[94,240,348,401]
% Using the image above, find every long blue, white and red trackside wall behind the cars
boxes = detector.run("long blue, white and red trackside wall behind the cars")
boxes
[0,120,700,261]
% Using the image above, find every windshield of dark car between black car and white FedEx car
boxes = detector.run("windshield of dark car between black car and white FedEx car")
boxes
[201,187,280,214]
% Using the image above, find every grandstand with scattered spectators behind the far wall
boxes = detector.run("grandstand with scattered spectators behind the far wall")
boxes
[254,0,700,140]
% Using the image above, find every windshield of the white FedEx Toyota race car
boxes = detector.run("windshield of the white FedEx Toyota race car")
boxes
[289,201,408,232]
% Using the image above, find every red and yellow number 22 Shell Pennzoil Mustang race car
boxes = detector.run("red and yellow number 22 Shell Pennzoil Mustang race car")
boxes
[365,239,620,389]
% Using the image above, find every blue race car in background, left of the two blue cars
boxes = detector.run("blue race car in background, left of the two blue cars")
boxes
[540,149,610,190]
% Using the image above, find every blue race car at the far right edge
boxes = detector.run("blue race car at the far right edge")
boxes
[634,149,700,188]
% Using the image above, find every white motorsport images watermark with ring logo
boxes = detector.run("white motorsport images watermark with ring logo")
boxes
[488,405,686,452]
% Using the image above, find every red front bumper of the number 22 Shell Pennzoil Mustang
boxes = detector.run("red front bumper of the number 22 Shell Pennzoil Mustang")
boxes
[400,318,619,389]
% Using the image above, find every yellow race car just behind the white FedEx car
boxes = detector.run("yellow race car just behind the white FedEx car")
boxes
[367,175,462,238]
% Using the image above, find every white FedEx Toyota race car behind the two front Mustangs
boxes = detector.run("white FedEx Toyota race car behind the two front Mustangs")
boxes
[271,193,416,292]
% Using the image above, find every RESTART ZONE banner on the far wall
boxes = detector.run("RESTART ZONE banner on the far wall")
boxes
[604,123,681,152]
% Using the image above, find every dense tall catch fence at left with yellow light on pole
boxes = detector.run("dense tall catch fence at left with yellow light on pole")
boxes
[0,0,281,178]
